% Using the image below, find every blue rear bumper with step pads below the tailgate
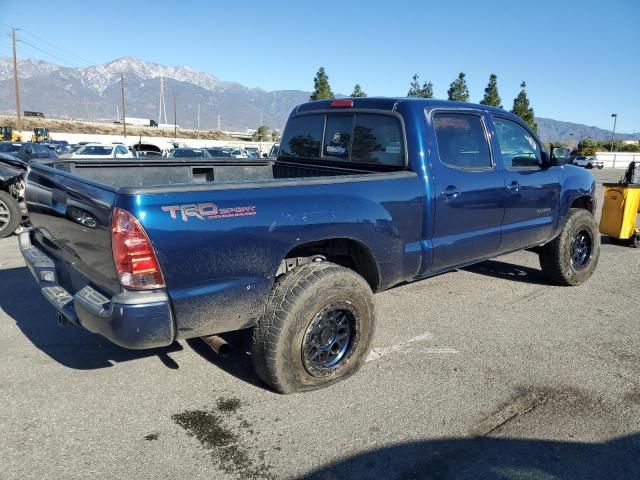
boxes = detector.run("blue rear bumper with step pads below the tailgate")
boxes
[19,232,175,349]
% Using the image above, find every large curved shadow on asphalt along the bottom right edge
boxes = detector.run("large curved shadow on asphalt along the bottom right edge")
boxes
[298,434,640,480]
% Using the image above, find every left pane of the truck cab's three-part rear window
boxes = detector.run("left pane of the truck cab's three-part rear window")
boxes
[280,115,324,158]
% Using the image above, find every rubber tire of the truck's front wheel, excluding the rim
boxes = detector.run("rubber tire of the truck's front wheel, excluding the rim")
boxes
[539,208,600,286]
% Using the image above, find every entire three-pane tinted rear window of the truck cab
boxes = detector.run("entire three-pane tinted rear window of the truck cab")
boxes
[280,112,405,167]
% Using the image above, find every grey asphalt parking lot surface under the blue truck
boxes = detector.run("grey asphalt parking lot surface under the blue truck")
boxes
[0,171,640,479]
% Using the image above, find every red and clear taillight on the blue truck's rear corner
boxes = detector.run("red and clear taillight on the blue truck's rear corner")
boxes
[111,208,164,290]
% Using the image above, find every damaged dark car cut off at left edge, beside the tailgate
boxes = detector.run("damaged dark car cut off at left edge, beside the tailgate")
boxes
[0,153,29,238]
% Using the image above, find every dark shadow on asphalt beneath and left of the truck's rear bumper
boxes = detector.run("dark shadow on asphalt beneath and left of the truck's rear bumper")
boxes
[0,267,183,370]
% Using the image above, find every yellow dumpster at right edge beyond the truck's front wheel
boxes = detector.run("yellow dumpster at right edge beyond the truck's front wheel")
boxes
[600,183,640,247]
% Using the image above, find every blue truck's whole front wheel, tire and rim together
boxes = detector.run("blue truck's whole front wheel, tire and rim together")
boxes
[540,208,600,286]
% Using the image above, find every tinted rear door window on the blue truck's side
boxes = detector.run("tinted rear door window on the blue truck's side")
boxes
[433,113,492,170]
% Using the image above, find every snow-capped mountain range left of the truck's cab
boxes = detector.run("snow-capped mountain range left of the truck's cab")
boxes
[0,57,309,129]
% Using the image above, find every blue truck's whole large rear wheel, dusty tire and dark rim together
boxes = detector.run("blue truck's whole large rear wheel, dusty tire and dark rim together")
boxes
[251,262,375,393]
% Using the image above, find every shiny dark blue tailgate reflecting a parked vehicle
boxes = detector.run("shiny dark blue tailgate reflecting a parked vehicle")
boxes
[25,163,120,294]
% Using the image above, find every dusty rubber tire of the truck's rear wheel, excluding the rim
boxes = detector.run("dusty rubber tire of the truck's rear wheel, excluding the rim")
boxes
[251,262,375,394]
